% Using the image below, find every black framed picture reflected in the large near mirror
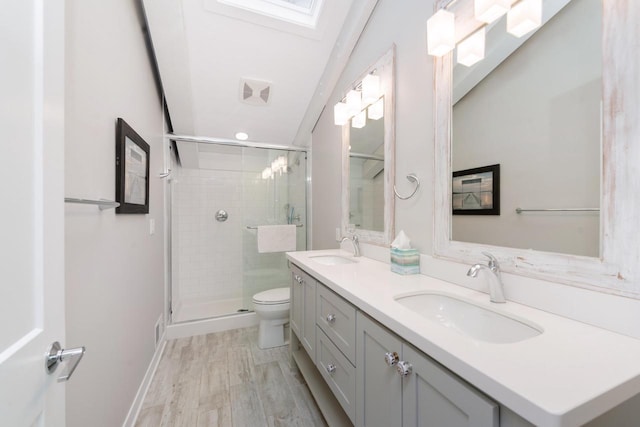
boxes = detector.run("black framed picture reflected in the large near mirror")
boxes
[451,165,500,215]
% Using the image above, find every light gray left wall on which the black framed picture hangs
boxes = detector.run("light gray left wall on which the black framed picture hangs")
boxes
[65,0,164,427]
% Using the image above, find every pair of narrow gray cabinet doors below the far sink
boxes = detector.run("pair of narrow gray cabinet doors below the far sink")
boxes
[290,265,317,363]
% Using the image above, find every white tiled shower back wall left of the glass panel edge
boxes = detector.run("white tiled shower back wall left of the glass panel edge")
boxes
[172,168,243,301]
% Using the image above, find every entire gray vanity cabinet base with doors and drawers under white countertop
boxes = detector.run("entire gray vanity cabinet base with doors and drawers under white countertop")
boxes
[291,264,502,427]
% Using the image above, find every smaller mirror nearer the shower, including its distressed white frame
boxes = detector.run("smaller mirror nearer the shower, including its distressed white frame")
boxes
[342,47,395,245]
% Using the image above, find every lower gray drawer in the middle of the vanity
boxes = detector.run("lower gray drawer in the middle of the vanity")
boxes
[316,328,356,424]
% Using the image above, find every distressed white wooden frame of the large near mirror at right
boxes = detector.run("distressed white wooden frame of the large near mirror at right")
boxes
[434,0,640,299]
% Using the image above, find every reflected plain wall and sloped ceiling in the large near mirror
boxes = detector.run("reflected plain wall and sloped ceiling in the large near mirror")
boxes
[451,0,602,257]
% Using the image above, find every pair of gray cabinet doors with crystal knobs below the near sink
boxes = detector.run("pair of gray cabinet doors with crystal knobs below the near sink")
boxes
[356,312,499,427]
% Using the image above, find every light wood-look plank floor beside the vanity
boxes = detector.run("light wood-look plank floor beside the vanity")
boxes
[136,327,326,427]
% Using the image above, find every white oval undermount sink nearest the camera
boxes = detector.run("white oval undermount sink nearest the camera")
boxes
[394,292,542,344]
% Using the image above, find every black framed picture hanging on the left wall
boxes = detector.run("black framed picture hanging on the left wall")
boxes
[116,118,149,214]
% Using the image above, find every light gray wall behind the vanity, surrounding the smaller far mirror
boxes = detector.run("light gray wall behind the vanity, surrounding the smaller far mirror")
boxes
[312,0,434,253]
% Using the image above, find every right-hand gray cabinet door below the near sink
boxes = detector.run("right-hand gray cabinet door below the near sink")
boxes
[402,344,499,427]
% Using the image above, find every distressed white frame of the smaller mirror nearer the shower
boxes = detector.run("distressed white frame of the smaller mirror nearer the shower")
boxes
[341,45,395,246]
